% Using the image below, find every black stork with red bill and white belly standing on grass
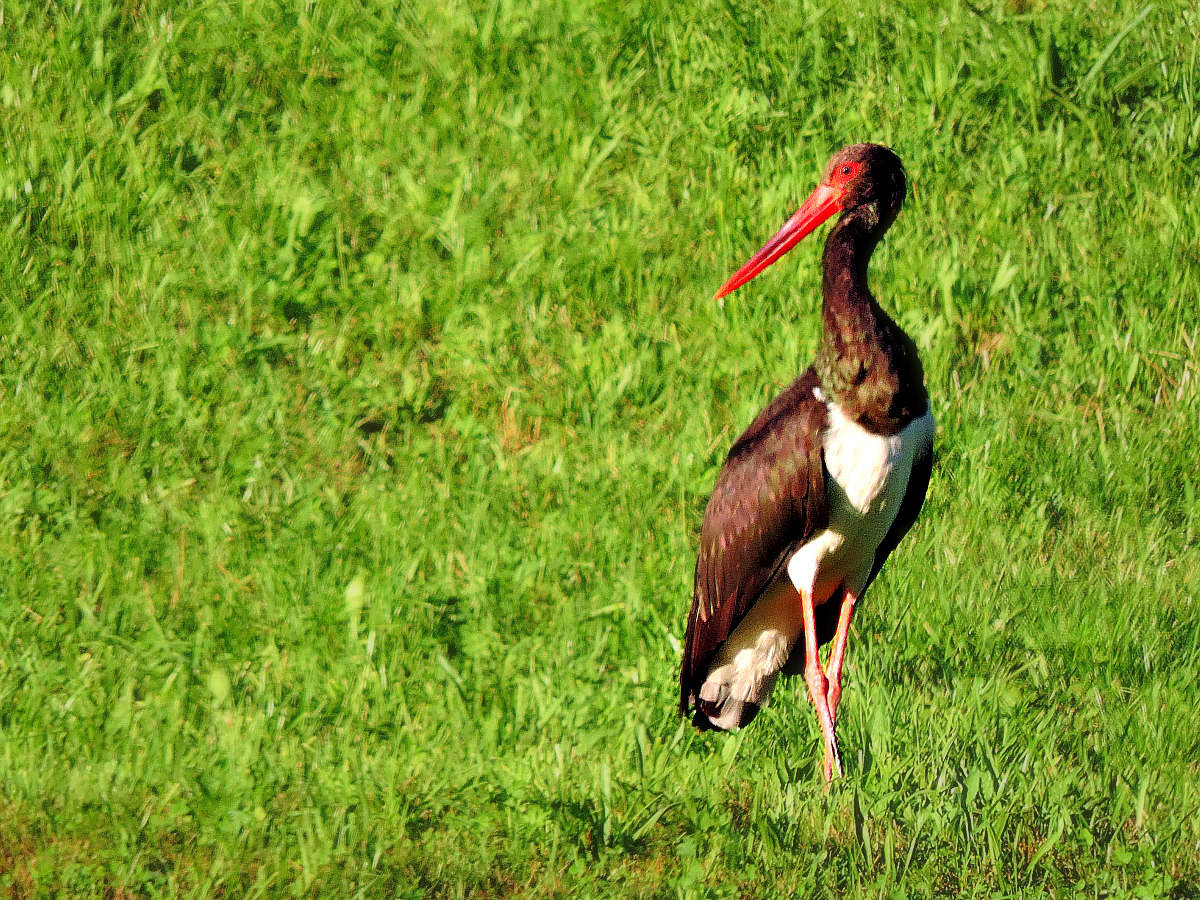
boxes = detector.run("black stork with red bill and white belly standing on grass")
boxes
[679,144,934,781]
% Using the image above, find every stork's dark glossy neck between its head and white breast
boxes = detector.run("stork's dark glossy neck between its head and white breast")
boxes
[816,209,929,434]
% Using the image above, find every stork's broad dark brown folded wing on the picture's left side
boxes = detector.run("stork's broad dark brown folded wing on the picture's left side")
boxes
[679,368,828,715]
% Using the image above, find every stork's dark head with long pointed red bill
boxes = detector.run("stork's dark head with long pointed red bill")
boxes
[716,144,907,299]
